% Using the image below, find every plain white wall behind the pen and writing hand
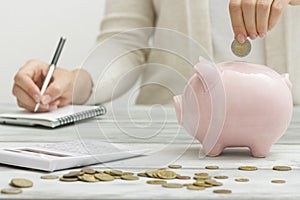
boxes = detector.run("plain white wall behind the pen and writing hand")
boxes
[0,0,105,103]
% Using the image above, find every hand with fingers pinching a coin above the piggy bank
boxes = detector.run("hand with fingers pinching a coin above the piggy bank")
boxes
[229,0,291,43]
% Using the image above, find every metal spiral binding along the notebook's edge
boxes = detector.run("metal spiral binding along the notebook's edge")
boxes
[58,106,106,125]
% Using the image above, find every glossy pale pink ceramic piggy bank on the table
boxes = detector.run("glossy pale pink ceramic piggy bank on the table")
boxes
[174,59,293,157]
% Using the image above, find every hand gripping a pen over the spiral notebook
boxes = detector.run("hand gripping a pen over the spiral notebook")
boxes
[12,60,93,112]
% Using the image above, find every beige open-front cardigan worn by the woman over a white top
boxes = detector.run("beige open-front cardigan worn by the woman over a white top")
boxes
[84,0,300,104]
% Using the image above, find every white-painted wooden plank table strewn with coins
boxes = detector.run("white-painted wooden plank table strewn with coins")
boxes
[0,105,300,199]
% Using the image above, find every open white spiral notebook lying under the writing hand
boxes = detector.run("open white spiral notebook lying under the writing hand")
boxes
[0,105,106,128]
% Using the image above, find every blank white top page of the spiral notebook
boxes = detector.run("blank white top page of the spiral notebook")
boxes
[0,105,98,121]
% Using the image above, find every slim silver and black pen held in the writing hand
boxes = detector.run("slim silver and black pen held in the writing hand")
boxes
[34,37,66,112]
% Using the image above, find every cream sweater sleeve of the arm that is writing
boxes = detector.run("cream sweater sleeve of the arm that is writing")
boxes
[82,0,154,104]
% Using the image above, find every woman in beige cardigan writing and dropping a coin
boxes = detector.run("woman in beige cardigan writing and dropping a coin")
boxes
[13,0,300,112]
